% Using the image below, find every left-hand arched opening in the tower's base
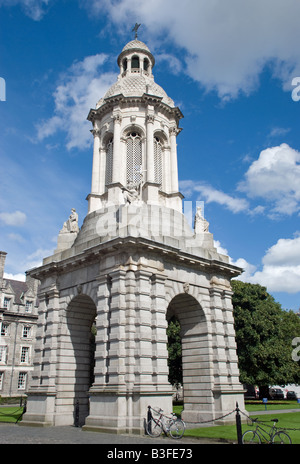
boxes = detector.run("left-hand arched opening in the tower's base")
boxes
[56,295,96,426]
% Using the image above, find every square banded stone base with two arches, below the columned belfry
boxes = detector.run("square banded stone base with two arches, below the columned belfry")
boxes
[23,204,243,433]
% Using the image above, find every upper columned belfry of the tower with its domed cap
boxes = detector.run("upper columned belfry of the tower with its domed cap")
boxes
[88,39,183,212]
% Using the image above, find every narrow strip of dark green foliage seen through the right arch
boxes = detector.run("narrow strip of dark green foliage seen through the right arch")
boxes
[167,317,182,386]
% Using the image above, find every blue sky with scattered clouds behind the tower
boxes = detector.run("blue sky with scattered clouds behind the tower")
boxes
[0,0,300,311]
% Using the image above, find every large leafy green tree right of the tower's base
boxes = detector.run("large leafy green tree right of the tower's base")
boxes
[232,280,300,396]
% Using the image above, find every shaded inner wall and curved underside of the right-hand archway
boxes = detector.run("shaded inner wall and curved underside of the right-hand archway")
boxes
[166,293,213,422]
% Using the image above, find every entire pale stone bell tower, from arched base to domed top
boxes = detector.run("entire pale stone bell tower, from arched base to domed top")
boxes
[23,31,243,433]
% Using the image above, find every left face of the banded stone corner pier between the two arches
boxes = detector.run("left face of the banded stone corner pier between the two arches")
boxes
[84,269,128,433]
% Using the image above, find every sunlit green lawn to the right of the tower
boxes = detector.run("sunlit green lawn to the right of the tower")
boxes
[174,402,300,444]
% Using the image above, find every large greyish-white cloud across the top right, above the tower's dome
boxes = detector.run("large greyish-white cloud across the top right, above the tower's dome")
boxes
[88,0,300,100]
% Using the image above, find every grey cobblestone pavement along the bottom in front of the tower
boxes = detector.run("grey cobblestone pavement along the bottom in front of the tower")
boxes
[0,424,220,446]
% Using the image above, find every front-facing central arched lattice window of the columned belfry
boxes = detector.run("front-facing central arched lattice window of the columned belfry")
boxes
[126,131,143,186]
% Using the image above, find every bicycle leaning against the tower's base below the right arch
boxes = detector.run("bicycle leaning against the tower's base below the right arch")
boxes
[146,406,185,439]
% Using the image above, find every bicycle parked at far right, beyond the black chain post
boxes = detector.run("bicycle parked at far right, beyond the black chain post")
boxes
[242,418,292,445]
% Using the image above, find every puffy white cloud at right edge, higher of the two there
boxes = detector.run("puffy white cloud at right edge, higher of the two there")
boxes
[238,143,300,215]
